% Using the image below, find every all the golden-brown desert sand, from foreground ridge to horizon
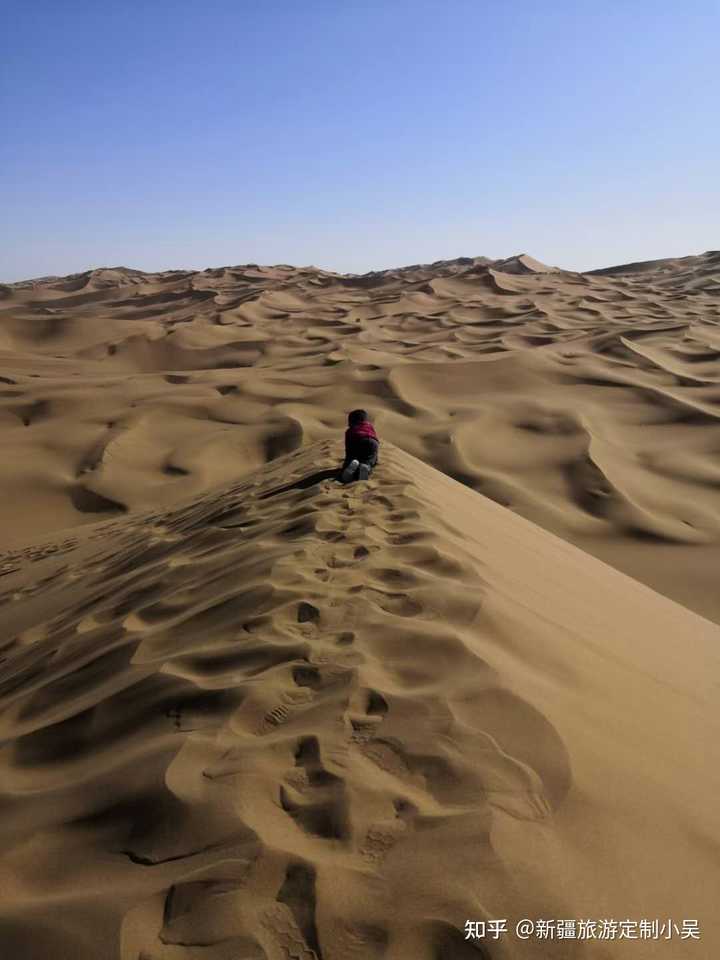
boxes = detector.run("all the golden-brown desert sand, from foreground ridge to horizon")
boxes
[0,253,720,960]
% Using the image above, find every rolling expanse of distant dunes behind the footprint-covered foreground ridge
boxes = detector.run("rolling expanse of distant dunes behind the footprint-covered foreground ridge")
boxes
[0,252,720,620]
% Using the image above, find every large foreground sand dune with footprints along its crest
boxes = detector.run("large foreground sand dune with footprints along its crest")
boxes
[0,441,720,960]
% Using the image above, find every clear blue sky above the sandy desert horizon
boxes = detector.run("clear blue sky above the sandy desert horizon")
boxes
[0,0,720,281]
